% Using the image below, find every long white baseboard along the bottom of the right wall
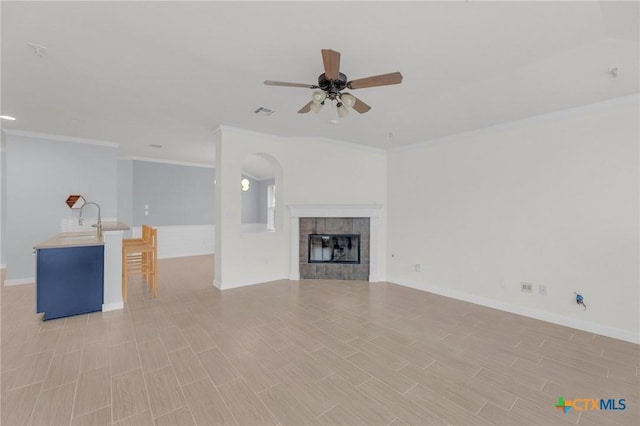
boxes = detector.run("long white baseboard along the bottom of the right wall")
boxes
[387,277,640,344]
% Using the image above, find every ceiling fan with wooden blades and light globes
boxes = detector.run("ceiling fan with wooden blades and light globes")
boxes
[264,49,402,118]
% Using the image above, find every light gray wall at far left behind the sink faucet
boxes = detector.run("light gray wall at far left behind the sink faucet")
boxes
[3,135,117,279]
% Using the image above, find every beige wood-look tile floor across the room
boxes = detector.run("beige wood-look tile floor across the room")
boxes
[1,256,640,426]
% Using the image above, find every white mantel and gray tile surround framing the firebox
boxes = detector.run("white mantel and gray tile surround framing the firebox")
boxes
[288,204,382,282]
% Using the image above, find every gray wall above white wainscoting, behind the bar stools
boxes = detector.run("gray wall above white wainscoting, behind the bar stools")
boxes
[132,161,215,226]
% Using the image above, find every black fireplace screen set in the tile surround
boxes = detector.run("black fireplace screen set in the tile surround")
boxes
[309,234,360,263]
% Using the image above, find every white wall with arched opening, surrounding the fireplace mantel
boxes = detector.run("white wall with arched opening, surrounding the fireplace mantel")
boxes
[215,127,386,289]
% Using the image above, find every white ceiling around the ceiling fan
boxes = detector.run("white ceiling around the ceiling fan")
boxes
[1,1,640,163]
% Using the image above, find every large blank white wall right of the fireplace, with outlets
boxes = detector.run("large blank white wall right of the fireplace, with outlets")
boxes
[387,97,640,342]
